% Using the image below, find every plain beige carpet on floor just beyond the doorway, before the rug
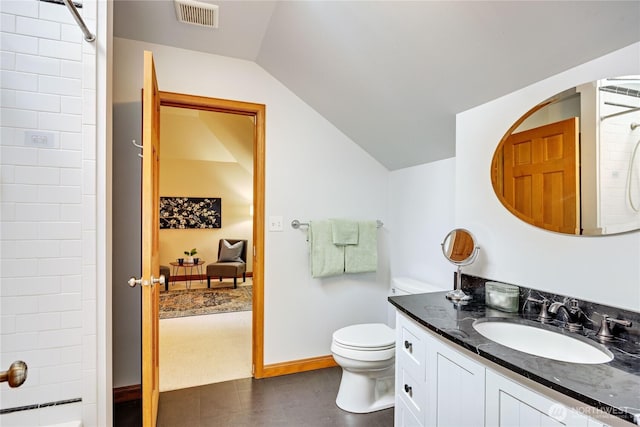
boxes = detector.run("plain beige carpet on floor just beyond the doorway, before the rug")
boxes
[160,283,252,392]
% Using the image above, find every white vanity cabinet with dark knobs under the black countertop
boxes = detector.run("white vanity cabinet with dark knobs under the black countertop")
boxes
[395,312,607,427]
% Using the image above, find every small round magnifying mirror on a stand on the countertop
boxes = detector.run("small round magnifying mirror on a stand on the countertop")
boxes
[440,228,480,304]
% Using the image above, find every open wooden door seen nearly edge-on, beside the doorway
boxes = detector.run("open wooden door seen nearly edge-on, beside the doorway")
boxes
[142,51,160,427]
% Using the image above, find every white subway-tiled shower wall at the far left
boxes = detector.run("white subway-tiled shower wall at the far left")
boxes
[0,0,97,426]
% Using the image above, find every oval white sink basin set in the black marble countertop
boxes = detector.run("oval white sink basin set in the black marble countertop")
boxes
[473,319,613,364]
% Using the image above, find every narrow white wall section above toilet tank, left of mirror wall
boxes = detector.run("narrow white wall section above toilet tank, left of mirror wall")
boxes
[389,158,457,289]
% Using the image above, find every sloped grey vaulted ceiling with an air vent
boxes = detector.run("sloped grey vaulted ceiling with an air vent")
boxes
[114,0,640,170]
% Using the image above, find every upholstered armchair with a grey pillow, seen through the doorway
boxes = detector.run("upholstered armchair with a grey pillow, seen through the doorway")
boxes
[207,239,247,288]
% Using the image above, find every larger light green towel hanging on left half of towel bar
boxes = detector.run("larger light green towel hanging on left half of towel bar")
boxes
[309,221,344,277]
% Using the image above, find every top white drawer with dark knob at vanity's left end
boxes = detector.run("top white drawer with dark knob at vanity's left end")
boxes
[396,314,425,379]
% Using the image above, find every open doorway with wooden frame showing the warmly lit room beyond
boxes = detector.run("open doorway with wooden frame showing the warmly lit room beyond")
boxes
[159,92,264,392]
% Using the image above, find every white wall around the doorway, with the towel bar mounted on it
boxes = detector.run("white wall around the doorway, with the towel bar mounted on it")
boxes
[114,39,389,366]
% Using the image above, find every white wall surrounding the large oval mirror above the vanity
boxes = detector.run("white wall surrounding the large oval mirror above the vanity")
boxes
[455,43,640,311]
